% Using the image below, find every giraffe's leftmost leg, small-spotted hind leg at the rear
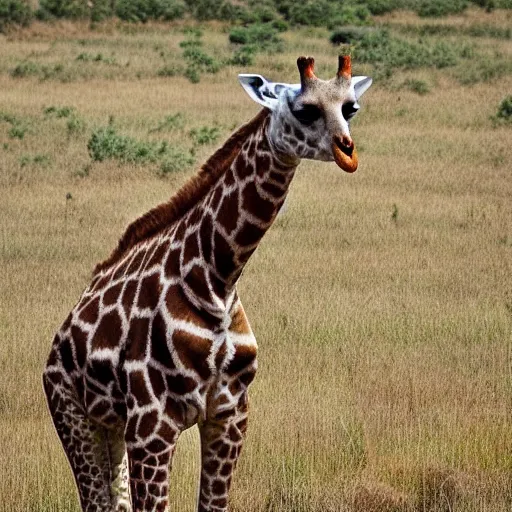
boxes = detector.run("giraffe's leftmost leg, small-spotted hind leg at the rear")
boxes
[43,371,112,512]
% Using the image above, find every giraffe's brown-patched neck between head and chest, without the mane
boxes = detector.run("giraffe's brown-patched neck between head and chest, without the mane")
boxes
[178,113,300,314]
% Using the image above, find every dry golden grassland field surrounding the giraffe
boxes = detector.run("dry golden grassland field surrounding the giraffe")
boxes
[0,10,512,512]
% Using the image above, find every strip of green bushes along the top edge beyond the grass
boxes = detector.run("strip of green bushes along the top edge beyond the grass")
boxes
[0,0,512,31]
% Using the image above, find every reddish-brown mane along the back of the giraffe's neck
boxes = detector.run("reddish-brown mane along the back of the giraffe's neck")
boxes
[93,108,270,275]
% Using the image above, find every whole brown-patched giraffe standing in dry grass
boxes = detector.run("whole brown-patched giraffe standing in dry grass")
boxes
[43,56,371,512]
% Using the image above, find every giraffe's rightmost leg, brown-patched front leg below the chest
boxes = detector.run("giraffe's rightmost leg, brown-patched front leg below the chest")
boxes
[198,391,247,512]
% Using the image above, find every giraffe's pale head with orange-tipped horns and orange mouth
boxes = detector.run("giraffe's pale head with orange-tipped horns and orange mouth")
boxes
[239,55,372,172]
